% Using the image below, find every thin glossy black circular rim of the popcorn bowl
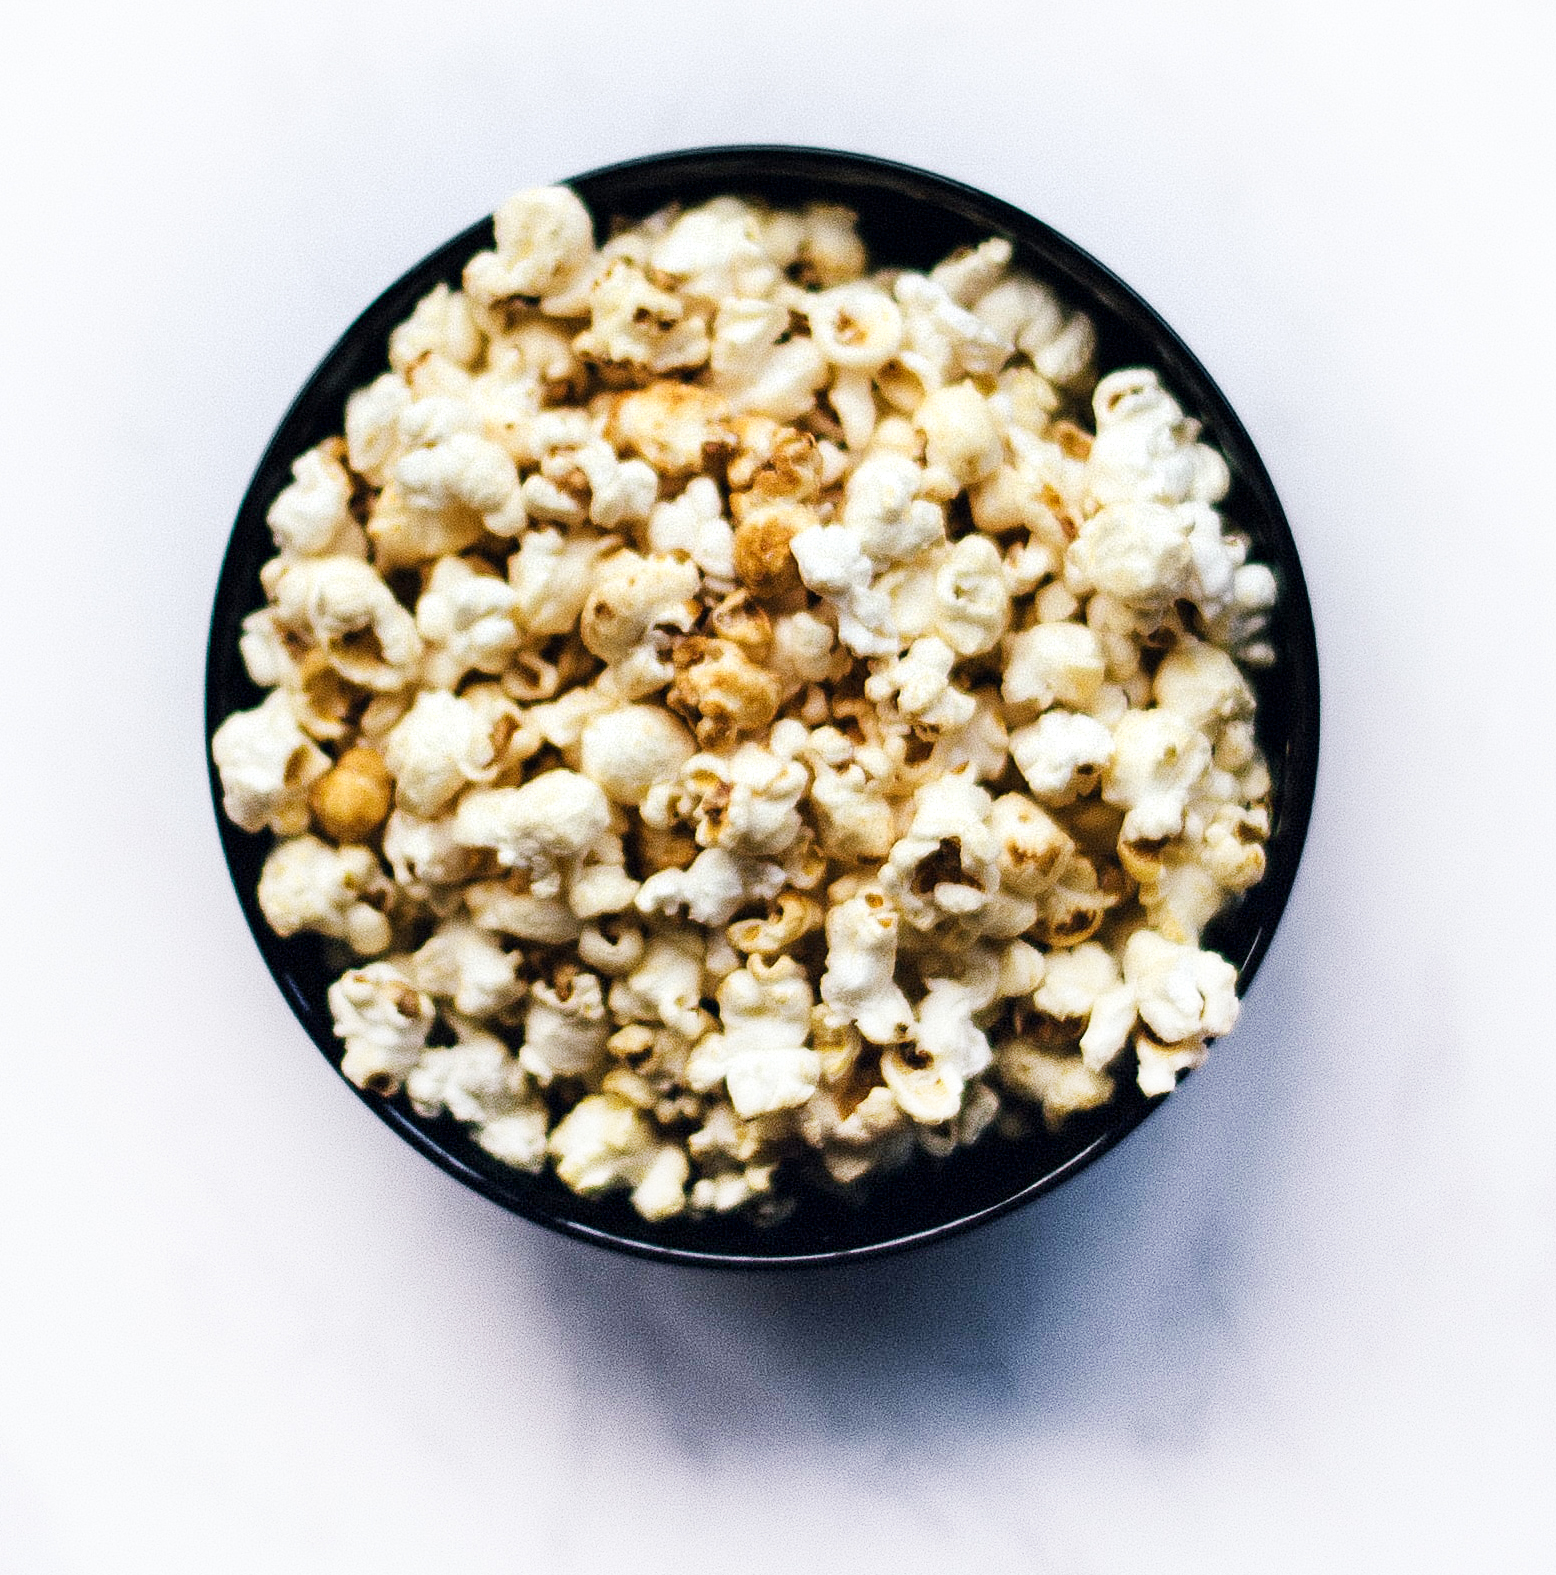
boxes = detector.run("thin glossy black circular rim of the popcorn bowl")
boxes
[203,143,1320,1269]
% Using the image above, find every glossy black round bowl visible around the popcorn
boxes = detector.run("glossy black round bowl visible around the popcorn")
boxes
[206,146,1318,1268]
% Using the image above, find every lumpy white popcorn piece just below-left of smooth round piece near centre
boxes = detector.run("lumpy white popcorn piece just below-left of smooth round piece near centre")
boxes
[454,770,611,898]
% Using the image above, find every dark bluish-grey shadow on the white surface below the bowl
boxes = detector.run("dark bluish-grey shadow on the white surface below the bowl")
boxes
[478,912,1313,1455]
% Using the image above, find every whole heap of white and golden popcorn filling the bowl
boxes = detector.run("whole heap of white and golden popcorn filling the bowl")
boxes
[213,187,1276,1219]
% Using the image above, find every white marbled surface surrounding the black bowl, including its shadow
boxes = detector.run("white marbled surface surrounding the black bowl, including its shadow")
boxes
[0,0,1556,1575]
